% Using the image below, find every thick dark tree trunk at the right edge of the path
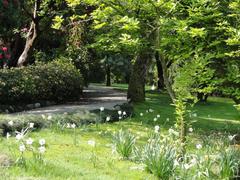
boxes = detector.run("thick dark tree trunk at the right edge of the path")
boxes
[127,53,151,102]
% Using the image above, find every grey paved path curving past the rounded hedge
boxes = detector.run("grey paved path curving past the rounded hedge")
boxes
[16,85,127,114]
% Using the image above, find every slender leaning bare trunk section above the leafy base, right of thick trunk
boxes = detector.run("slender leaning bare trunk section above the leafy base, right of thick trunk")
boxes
[159,55,176,102]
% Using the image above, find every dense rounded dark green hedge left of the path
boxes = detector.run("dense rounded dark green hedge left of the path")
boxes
[0,60,83,104]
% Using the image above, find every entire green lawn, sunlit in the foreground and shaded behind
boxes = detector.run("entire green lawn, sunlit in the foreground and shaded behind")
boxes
[0,85,240,180]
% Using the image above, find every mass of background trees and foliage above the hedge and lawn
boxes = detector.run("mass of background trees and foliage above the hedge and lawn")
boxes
[0,0,240,103]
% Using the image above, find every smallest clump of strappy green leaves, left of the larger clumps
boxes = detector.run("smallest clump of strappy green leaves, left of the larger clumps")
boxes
[113,129,136,159]
